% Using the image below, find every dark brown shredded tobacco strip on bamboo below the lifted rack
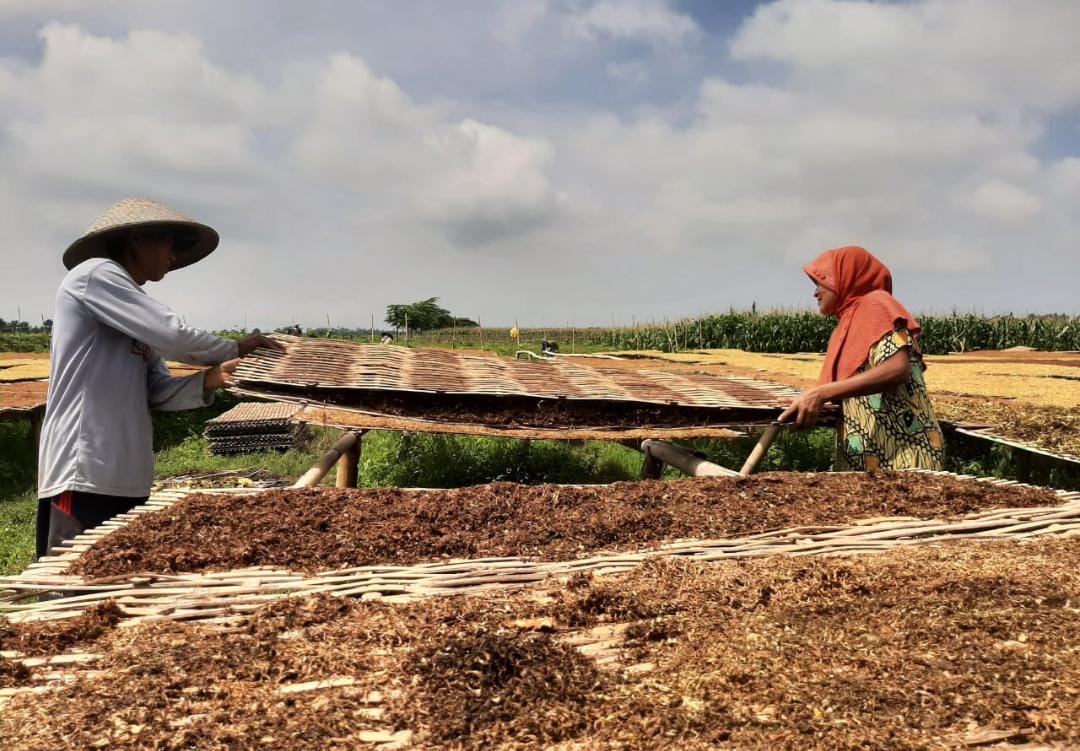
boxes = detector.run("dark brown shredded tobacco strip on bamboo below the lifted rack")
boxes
[71,472,1059,578]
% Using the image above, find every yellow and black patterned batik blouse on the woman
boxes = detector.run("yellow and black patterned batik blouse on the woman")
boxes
[836,328,945,471]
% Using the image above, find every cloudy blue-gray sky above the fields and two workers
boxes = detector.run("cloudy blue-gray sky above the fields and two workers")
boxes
[0,0,1080,330]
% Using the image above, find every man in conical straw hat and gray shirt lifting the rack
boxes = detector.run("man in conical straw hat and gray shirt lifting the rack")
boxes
[37,199,282,558]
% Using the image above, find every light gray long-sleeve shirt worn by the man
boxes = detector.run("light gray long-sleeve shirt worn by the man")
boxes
[38,258,238,498]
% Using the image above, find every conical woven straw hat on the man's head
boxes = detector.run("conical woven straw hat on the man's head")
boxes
[64,198,218,270]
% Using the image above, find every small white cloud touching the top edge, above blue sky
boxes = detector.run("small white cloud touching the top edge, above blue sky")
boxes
[566,0,701,44]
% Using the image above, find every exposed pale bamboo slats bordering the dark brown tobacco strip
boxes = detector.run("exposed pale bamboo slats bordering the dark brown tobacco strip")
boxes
[0,472,1080,622]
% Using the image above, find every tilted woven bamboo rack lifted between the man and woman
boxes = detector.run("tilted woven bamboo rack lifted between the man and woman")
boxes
[235,336,798,411]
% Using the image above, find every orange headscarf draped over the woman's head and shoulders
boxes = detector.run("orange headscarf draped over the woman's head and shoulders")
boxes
[804,245,921,384]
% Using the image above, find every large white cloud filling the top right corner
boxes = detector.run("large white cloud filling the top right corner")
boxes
[731,0,1080,112]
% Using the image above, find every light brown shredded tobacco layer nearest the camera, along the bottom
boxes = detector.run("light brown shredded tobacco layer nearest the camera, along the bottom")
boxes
[3,539,1080,751]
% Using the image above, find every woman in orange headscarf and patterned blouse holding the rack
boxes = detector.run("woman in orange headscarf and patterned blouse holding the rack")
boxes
[780,245,944,470]
